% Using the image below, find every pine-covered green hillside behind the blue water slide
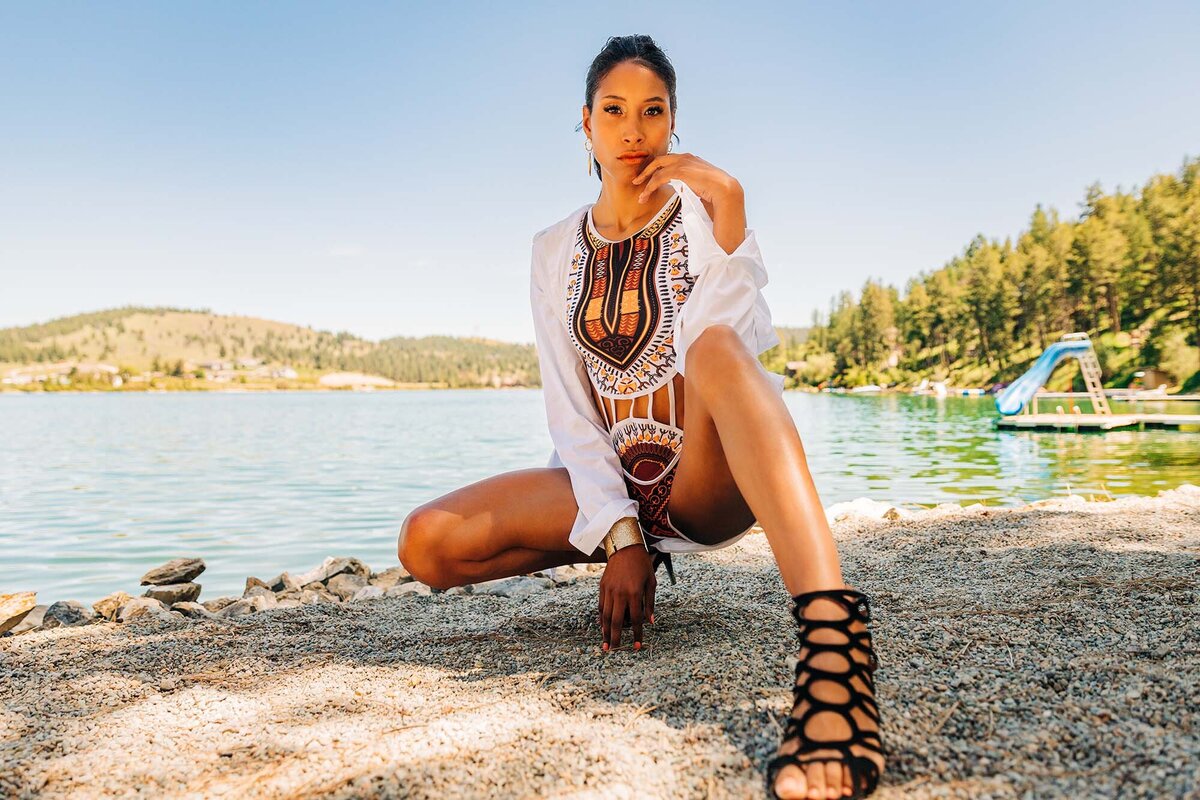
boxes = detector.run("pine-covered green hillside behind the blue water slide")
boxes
[786,158,1200,390]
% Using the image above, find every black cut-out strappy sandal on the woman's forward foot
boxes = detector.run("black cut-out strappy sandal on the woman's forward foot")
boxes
[767,589,888,800]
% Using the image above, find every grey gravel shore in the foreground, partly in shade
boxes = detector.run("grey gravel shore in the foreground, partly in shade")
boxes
[0,486,1200,799]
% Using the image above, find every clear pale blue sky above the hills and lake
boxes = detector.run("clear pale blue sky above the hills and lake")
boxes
[0,1,1200,342]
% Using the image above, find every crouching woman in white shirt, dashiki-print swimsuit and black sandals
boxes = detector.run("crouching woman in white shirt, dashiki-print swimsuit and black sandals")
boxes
[400,36,886,798]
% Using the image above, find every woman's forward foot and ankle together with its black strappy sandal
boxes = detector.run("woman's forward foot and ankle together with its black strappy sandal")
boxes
[768,589,884,800]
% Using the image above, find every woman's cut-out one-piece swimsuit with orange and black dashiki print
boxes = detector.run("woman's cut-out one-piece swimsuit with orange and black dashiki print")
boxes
[566,194,696,543]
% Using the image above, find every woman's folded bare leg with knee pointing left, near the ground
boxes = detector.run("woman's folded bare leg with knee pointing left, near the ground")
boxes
[397,467,604,589]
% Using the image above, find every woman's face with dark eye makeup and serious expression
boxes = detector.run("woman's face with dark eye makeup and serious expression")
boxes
[583,61,674,182]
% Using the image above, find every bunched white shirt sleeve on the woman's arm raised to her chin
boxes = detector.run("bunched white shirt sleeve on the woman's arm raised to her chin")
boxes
[671,181,785,391]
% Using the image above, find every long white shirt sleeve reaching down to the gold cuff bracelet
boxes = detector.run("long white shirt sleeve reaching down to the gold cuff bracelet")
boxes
[529,232,637,555]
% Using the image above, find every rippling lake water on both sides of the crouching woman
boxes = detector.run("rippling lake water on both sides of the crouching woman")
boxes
[0,390,1200,603]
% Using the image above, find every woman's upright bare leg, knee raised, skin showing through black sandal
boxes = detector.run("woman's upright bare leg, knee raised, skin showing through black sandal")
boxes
[667,325,882,798]
